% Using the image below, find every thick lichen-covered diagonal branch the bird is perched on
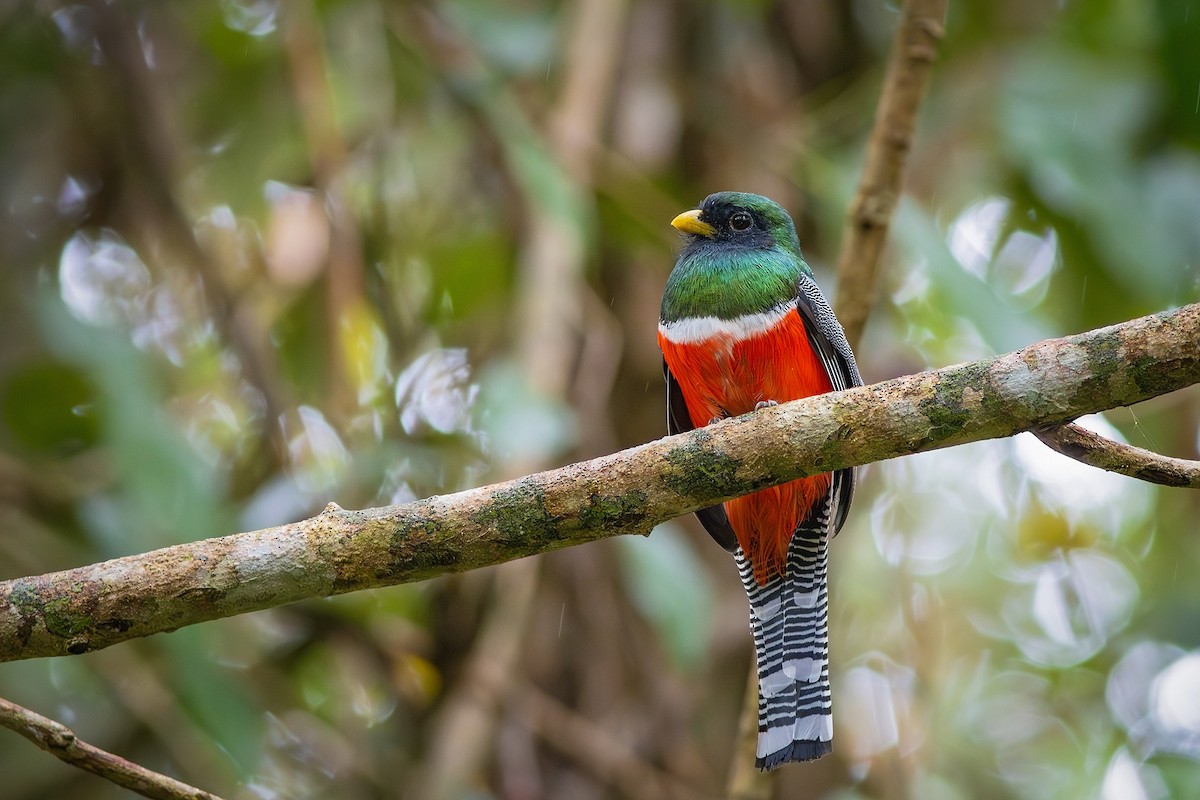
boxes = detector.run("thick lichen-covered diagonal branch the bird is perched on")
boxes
[0,303,1200,660]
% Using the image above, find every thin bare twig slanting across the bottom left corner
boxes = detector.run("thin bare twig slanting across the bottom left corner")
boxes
[0,698,221,800]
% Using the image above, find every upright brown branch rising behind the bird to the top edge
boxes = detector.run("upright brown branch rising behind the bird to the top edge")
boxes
[835,0,948,348]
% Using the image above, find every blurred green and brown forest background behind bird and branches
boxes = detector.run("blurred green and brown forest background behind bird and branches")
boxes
[0,0,1200,800]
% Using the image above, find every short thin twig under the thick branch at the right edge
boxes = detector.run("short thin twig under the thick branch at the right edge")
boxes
[1031,423,1200,489]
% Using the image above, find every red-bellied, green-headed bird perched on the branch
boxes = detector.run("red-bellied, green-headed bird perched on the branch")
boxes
[659,192,863,770]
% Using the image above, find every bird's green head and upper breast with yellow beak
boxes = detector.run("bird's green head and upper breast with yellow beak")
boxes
[660,192,810,321]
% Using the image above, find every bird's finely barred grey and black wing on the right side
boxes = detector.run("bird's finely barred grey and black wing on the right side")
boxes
[796,273,863,534]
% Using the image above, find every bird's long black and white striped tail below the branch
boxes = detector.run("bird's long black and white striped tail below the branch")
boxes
[734,513,833,770]
